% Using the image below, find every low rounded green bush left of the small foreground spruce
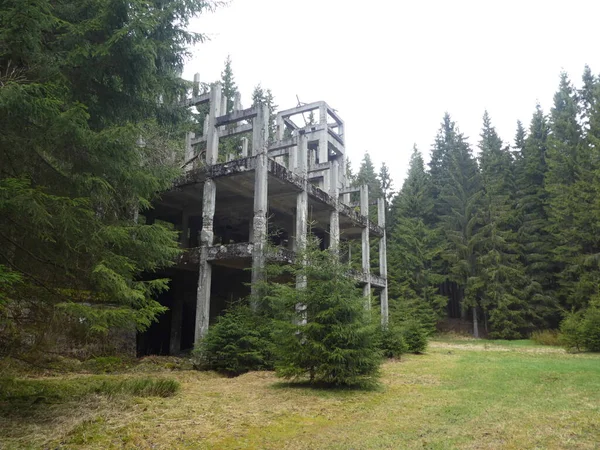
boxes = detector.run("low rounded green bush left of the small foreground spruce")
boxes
[193,306,273,376]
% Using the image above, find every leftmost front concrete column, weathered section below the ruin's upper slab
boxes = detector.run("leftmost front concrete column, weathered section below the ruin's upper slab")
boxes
[194,178,217,344]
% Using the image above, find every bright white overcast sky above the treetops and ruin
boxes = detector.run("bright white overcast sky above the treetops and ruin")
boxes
[184,0,600,189]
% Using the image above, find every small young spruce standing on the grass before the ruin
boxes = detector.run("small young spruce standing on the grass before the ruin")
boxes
[263,239,381,386]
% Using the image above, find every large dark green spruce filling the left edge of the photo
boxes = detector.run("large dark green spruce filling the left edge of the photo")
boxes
[0,0,210,352]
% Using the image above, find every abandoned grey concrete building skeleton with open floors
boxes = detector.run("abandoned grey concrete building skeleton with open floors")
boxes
[137,75,388,355]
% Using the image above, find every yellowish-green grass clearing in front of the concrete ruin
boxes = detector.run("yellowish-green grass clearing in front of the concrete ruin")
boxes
[0,338,600,449]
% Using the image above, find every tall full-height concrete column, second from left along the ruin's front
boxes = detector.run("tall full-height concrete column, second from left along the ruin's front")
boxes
[251,105,269,309]
